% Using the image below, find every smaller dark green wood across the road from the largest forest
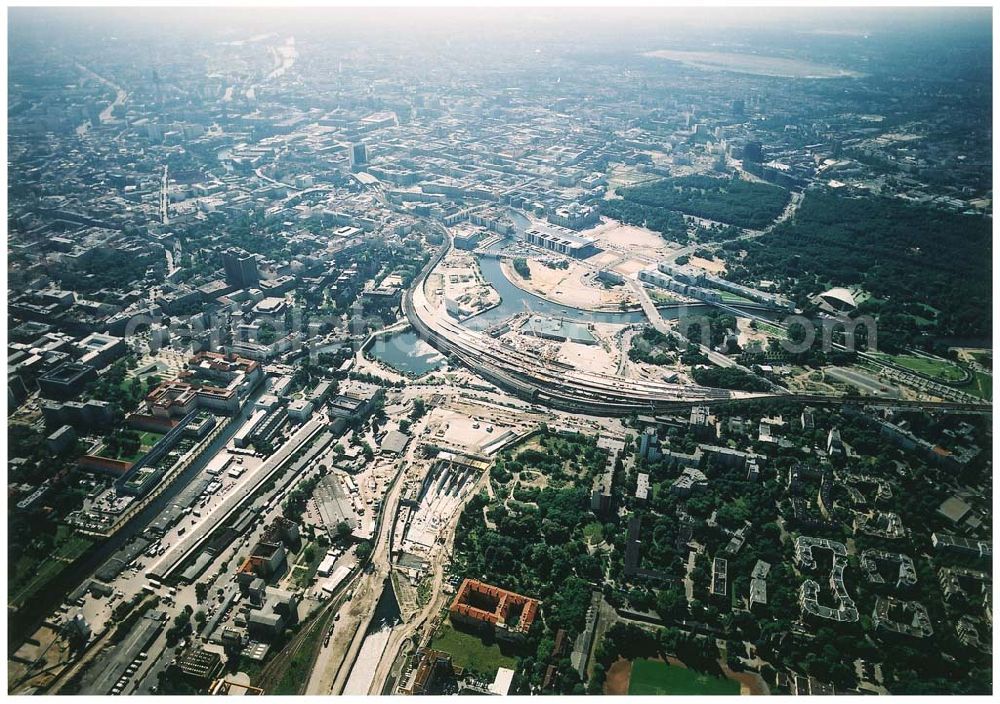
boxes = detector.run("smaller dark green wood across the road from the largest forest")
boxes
[602,176,788,234]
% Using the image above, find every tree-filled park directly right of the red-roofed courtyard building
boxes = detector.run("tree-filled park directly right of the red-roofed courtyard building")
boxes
[454,431,608,694]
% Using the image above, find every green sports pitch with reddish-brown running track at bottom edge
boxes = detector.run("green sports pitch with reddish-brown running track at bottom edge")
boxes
[604,658,740,696]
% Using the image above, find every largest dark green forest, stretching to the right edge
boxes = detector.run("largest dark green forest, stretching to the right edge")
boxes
[729,192,992,349]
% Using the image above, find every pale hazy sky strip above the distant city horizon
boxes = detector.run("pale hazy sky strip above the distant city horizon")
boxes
[9,7,992,39]
